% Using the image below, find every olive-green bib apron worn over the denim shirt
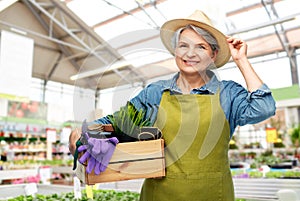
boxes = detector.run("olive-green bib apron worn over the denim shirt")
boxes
[140,91,234,201]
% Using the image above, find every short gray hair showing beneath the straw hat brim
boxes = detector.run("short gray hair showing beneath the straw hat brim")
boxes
[171,24,220,51]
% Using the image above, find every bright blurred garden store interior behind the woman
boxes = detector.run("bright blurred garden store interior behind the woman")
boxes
[0,0,300,201]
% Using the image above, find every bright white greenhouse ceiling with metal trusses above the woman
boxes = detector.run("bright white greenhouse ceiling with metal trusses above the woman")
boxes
[0,0,300,89]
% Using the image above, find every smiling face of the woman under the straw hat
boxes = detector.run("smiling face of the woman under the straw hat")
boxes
[175,29,217,74]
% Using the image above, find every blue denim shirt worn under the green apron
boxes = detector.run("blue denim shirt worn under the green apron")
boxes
[94,71,276,136]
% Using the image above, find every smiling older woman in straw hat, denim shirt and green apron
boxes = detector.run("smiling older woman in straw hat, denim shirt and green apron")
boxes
[70,11,275,201]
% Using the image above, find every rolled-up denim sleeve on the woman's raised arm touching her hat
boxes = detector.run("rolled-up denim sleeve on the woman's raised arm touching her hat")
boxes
[221,82,276,136]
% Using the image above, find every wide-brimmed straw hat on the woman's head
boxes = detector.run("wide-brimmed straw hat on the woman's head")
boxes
[160,10,231,67]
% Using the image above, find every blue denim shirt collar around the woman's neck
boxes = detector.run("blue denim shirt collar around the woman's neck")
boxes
[164,71,220,94]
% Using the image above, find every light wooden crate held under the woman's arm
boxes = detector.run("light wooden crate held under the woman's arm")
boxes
[76,139,165,185]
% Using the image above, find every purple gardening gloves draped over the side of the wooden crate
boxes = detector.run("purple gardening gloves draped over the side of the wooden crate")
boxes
[78,132,119,175]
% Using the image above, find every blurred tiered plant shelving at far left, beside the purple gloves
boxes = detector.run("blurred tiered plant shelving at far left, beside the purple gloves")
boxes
[0,117,71,160]
